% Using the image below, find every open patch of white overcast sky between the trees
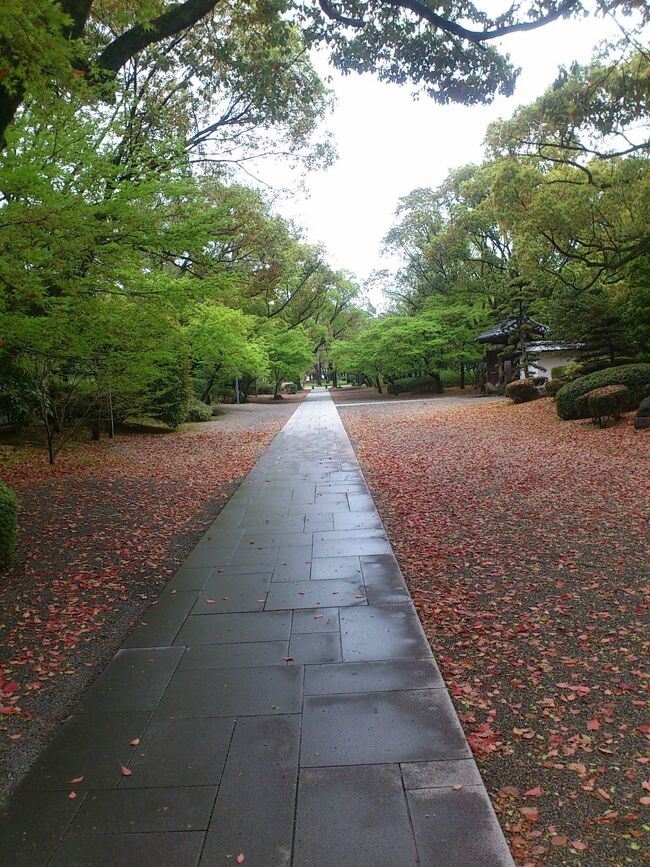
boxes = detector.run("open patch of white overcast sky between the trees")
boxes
[256,8,620,303]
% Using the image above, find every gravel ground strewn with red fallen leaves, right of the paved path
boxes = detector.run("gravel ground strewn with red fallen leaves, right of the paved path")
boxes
[341,399,650,867]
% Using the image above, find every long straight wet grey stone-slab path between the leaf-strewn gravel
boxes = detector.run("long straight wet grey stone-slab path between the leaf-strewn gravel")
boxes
[0,391,512,867]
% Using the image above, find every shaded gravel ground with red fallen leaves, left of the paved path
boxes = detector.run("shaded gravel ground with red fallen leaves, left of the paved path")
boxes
[0,396,302,799]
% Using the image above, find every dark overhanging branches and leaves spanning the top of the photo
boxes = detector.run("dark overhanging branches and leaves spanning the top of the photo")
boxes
[0,0,648,147]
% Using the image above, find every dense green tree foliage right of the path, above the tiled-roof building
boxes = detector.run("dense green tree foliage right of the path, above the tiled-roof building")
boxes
[333,41,650,396]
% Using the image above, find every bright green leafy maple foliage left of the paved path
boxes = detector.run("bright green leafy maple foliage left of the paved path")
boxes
[0,87,354,461]
